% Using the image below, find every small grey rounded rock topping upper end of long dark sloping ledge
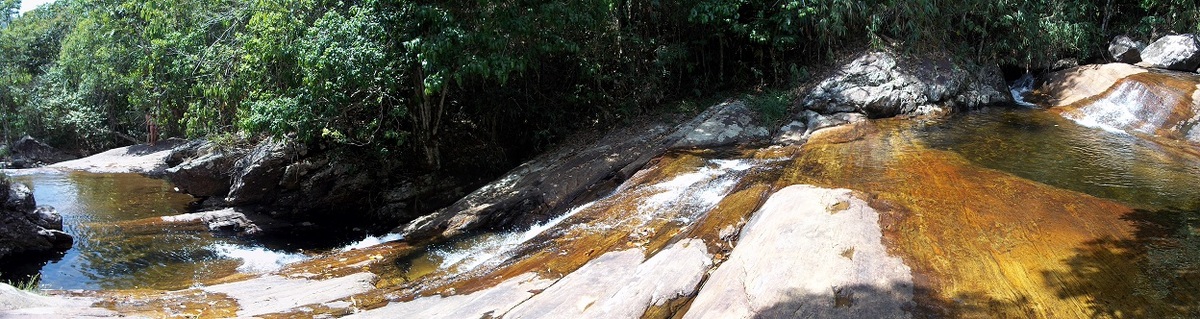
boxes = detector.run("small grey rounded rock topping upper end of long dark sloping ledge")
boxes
[672,101,769,149]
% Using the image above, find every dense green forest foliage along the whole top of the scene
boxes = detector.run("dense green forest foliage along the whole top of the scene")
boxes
[0,0,1200,167]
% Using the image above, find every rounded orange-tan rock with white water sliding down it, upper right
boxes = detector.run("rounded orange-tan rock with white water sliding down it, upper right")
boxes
[1038,64,1200,143]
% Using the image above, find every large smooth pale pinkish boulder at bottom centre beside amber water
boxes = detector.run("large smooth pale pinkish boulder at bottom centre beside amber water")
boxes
[684,186,913,318]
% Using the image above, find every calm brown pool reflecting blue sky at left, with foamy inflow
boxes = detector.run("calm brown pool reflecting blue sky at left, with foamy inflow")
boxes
[2,170,305,289]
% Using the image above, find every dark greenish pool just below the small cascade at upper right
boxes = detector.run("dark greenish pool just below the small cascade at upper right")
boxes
[917,109,1200,211]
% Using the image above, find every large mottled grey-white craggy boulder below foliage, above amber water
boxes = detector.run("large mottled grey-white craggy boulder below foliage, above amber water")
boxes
[802,52,1012,118]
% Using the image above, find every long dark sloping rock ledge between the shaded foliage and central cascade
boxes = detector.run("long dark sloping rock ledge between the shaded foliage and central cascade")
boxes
[394,101,768,240]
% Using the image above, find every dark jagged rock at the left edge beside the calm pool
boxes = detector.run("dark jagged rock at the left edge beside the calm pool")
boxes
[0,180,74,260]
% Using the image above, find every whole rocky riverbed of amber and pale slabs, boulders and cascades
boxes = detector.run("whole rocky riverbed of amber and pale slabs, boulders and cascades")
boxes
[0,47,1200,318]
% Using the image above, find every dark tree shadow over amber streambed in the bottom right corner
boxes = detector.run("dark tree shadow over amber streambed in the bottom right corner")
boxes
[1043,210,1200,318]
